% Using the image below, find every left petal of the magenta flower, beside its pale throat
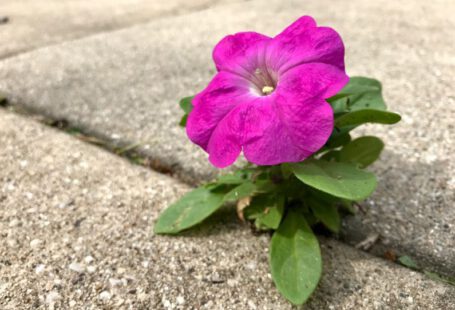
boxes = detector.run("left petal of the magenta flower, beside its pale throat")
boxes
[186,72,252,151]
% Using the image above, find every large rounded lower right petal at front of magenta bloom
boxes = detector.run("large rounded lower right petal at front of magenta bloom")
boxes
[243,90,333,165]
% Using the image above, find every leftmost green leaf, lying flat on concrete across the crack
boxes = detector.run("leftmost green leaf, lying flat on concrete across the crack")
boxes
[154,187,224,234]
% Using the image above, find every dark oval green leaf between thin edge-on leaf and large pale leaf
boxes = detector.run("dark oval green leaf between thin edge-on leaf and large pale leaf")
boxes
[338,136,384,168]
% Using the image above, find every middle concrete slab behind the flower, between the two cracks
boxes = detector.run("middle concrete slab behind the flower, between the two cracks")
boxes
[0,0,455,276]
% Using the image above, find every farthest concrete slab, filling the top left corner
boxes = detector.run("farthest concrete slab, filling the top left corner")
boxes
[0,0,246,58]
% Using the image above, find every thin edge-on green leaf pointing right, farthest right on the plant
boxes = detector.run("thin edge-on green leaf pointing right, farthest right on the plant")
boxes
[335,109,401,128]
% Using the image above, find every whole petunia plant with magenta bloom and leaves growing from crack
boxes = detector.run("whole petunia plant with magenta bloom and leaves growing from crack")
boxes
[154,16,400,304]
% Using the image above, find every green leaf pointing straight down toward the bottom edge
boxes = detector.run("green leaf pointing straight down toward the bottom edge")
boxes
[270,210,322,305]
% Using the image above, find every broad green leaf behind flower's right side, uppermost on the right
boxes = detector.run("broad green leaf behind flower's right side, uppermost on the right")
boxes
[328,77,386,114]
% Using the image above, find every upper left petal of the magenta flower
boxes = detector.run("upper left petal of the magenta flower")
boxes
[213,32,271,76]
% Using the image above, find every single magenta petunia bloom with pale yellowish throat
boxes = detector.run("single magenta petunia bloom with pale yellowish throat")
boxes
[187,16,349,168]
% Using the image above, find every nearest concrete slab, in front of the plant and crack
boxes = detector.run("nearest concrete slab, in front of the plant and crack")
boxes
[0,110,455,310]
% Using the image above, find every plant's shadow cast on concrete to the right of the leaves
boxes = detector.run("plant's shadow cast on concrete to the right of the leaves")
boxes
[341,151,455,277]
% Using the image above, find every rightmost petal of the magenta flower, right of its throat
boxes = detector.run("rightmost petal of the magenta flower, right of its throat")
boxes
[277,63,349,99]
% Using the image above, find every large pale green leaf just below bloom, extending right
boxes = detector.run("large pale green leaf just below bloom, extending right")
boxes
[293,159,377,200]
